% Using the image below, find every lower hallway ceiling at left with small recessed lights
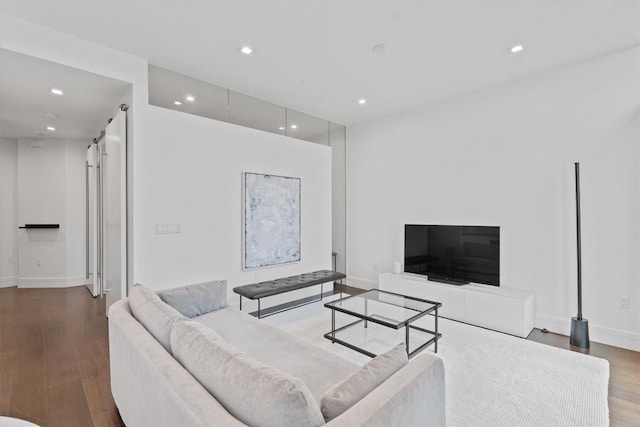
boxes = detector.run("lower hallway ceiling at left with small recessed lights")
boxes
[0,49,130,143]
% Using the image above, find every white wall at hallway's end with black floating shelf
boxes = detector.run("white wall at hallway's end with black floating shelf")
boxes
[16,139,87,287]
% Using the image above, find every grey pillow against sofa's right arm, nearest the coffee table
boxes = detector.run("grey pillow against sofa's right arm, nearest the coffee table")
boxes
[320,344,409,422]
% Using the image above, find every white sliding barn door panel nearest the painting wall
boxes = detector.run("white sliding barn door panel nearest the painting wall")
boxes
[101,111,127,312]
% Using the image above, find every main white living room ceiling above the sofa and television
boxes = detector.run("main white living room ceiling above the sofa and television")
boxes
[0,0,640,125]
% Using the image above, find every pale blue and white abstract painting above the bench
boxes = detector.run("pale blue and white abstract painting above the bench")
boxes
[243,172,300,269]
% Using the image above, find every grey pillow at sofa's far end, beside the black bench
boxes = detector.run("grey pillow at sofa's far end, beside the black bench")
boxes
[158,280,227,317]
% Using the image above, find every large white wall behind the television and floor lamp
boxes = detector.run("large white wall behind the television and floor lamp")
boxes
[347,48,640,350]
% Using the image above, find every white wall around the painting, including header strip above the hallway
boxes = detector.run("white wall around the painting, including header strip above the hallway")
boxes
[0,14,331,303]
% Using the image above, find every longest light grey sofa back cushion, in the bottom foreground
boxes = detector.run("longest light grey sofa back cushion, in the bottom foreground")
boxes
[171,321,324,427]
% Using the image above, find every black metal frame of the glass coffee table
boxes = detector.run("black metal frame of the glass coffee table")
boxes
[324,289,442,358]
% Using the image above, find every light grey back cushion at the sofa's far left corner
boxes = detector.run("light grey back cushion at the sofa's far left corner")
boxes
[129,284,184,353]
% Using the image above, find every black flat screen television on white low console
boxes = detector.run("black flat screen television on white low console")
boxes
[404,224,500,286]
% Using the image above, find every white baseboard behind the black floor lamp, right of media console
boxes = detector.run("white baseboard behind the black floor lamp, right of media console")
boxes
[535,314,640,351]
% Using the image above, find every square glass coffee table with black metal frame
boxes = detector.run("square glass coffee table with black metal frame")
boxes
[324,289,442,358]
